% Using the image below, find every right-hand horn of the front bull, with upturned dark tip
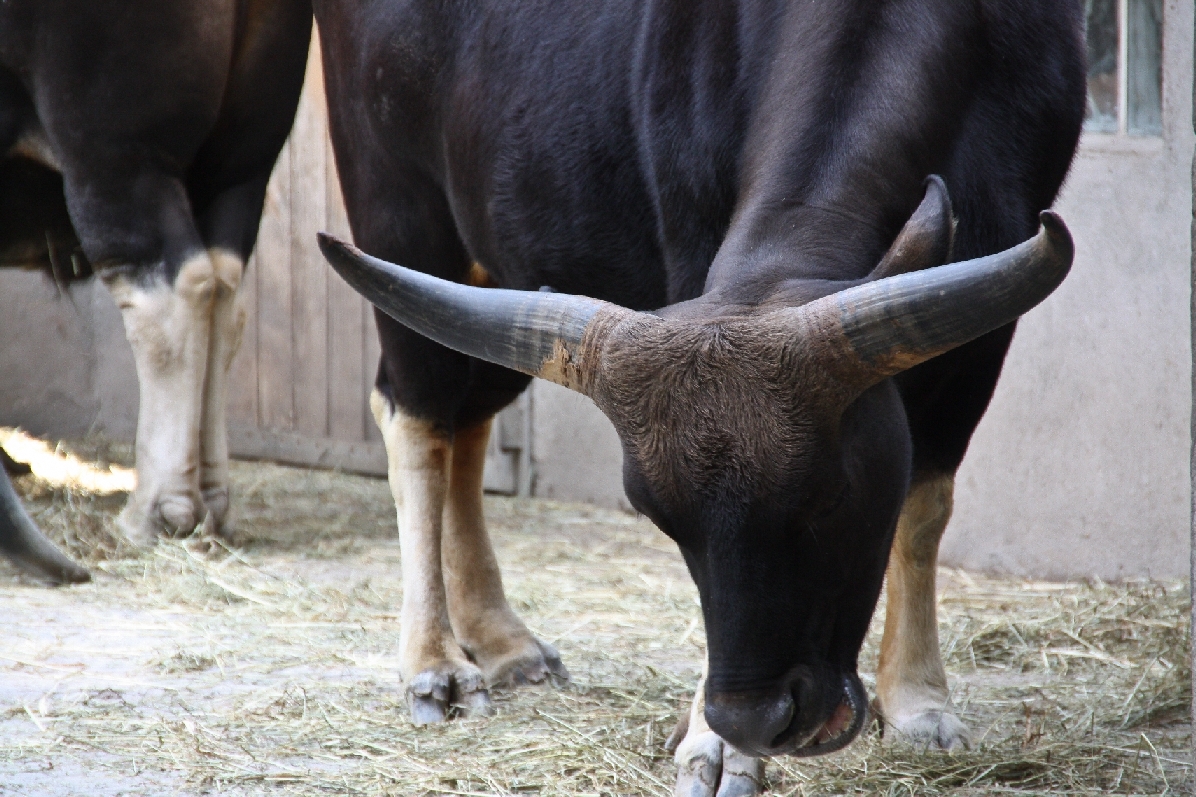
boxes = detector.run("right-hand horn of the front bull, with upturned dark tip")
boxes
[797,211,1075,388]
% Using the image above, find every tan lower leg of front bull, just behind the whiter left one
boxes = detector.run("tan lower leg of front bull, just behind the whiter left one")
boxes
[440,421,569,686]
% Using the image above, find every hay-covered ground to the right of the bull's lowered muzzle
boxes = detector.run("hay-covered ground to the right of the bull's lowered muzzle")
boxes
[780,571,1191,795]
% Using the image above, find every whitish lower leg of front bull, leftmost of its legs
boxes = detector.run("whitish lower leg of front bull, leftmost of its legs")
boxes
[370,390,490,725]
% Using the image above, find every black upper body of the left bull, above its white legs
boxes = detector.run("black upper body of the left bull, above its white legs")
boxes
[0,0,311,282]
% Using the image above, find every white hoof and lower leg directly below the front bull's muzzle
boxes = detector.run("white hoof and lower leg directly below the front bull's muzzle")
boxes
[665,671,764,797]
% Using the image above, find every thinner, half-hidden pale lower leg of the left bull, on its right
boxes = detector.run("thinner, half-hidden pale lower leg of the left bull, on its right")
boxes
[200,249,246,536]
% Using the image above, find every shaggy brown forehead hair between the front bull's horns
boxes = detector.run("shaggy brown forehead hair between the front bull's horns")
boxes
[583,312,842,501]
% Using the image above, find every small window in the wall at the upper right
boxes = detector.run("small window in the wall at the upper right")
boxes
[1084,0,1163,135]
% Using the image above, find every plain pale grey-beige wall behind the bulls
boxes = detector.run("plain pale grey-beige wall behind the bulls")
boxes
[0,6,1194,578]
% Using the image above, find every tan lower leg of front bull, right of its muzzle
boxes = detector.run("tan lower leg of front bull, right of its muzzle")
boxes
[877,475,969,750]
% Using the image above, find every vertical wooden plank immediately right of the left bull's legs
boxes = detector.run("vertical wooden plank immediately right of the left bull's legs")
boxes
[254,142,294,431]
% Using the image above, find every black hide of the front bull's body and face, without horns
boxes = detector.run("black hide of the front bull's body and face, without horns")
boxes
[315,0,1085,754]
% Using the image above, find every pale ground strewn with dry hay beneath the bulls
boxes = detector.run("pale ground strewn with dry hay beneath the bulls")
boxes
[0,430,1191,797]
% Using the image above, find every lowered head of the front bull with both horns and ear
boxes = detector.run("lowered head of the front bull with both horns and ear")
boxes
[321,180,1073,755]
